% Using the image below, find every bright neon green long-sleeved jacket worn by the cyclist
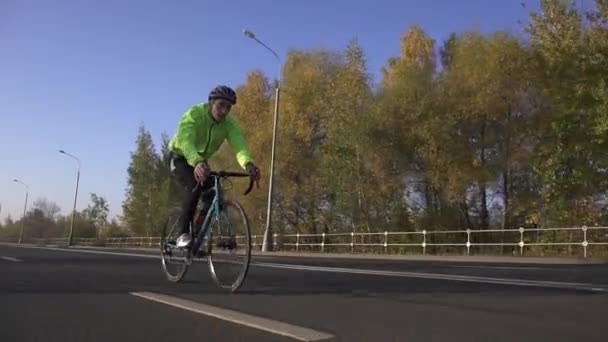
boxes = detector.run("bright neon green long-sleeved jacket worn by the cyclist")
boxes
[169,103,253,169]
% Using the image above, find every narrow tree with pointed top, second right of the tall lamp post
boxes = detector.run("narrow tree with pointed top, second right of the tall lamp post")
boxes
[319,39,375,234]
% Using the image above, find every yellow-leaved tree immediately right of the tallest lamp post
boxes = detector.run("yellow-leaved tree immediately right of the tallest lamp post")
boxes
[277,49,339,233]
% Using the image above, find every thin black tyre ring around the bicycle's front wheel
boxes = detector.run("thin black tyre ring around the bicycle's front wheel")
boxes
[207,200,251,292]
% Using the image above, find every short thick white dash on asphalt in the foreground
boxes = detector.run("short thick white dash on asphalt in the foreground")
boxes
[131,292,335,342]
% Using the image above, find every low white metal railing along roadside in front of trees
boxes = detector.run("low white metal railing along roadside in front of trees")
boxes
[3,226,608,258]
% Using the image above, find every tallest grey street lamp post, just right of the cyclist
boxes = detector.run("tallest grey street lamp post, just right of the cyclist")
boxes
[243,30,282,252]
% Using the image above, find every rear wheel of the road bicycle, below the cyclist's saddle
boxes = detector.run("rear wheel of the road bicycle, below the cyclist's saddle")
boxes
[160,207,192,283]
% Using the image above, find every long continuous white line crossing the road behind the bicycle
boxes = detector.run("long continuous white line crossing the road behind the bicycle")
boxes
[2,245,608,292]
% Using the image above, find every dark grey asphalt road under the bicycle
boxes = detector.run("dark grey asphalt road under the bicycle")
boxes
[0,245,608,342]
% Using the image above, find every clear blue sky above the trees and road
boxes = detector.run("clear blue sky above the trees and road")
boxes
[0,0,538,222]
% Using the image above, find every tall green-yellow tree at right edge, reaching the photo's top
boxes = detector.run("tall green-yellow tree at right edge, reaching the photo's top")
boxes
[528,0,608,224]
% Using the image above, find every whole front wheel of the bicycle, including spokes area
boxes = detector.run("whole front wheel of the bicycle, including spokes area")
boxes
[207,200,251,292]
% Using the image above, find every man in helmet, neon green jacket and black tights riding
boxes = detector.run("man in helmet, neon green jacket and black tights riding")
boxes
[169,85,260,247]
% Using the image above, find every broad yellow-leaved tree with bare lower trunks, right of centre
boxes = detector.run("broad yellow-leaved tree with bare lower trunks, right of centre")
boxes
[443,32,535,229]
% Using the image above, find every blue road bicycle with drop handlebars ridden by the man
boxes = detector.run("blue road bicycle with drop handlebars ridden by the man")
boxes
[160,171,259,292]
